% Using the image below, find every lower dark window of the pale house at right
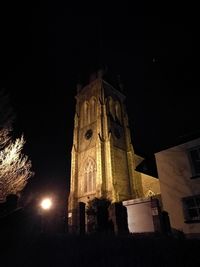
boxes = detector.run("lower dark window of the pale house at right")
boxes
[183,195,200,223]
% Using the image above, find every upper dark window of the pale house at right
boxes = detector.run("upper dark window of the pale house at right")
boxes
[188,147,200,178]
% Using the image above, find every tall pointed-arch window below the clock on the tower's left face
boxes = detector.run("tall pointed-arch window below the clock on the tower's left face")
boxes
[83,158,96,193]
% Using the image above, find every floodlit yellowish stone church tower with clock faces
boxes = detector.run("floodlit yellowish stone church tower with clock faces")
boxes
[68,71,142,230]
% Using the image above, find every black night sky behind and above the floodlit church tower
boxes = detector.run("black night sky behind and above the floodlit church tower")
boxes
[0,3,200,203]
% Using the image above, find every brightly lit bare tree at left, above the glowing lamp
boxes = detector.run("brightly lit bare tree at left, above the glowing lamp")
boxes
[0,89,33,201]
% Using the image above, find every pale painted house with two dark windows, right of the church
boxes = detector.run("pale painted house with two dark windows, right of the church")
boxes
[155,138,200,238]
